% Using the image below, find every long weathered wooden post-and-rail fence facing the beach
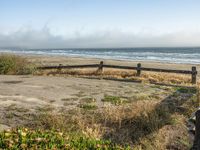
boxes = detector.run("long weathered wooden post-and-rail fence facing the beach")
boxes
[38,61,197,84]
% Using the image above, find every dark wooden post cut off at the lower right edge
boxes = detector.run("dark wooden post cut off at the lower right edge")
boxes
[191,110,200,150]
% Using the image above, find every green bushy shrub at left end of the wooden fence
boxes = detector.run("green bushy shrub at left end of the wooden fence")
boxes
[0,55,36,75]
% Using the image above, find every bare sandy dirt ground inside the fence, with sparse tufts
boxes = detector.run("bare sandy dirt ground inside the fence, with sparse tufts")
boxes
[0,75,172,129]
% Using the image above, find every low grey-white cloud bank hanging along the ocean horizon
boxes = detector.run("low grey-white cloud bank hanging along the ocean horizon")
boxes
[0,26,200,48]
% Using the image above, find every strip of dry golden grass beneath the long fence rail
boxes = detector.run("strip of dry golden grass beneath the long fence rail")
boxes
[38,69,191,85]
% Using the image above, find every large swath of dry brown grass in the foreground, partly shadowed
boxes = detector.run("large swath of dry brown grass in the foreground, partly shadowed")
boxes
[24,85,198,150]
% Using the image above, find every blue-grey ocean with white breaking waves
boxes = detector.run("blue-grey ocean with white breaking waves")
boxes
[0,47,200,64]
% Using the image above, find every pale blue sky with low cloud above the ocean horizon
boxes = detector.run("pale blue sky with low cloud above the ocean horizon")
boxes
[0,0,200,48]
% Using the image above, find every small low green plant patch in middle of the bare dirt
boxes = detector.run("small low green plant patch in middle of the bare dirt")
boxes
[101,95,130,105]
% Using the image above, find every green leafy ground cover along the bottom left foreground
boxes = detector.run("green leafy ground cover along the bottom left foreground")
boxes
[0,128,127,150]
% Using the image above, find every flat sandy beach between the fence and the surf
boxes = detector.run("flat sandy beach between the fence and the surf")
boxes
[28,55,200,70]
